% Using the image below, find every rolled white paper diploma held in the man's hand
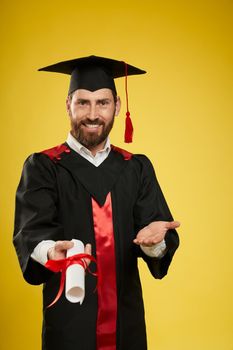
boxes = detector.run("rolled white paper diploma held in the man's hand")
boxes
[65,239,85,304]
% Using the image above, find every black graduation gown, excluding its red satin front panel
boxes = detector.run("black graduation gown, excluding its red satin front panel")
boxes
[14,144,179,350]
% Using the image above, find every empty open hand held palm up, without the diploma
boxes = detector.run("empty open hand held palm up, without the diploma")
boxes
[133,221,180,247]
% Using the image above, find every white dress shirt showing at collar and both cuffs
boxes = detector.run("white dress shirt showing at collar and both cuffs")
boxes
[31,133,166,265]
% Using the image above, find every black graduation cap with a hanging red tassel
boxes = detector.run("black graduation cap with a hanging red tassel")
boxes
[39,55,146,142]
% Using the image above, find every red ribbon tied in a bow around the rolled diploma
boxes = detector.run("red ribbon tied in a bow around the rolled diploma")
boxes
[45,253,97,307]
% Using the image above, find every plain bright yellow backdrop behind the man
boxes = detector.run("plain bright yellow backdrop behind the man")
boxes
[0,0,233,350]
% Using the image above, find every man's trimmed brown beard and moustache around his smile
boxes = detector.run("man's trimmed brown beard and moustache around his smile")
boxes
[71,113,115,149]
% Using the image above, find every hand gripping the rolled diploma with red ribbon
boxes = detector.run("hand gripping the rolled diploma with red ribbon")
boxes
[48,241,91,265]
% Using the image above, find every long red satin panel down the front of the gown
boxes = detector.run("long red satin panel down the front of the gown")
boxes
[92,193,117,350]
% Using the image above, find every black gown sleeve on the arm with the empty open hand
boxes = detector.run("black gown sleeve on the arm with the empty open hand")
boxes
[134,155,179,279]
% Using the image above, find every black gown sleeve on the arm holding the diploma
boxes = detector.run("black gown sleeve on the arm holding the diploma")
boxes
[13,154,63,284]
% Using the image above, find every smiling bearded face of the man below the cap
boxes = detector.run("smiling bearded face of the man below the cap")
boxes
[66,89,120,155]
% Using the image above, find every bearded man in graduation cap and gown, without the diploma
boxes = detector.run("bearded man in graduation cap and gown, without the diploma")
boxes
[14,56,179,350]
